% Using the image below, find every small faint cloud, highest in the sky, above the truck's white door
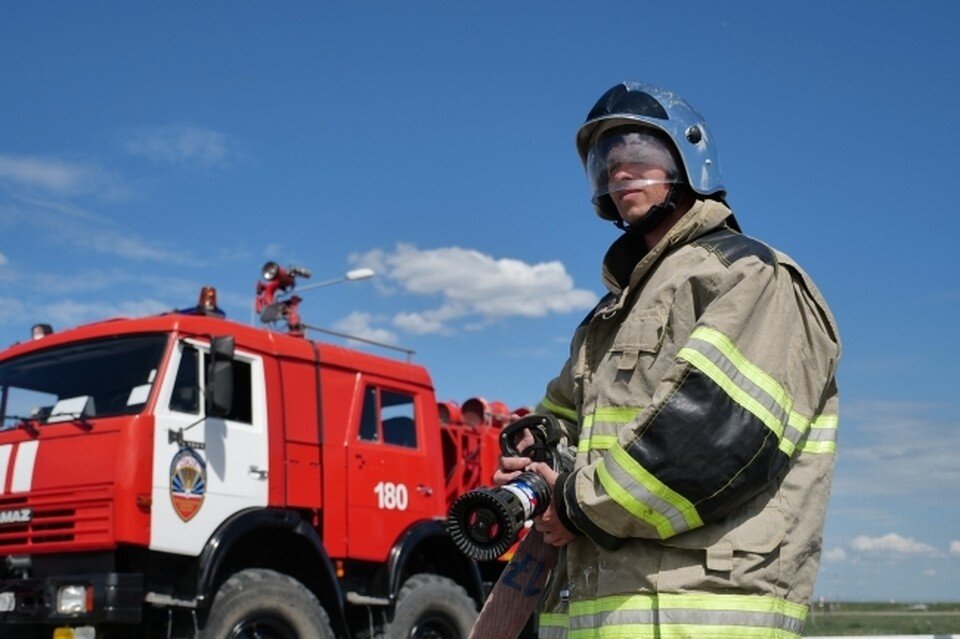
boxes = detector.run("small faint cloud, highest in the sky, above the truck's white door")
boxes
[123,125,234,167]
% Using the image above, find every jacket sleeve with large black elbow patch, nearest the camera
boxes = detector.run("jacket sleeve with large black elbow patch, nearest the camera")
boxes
[555,255,839,549]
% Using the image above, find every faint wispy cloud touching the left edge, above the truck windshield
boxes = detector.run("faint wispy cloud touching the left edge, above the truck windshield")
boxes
[0,154,127,198]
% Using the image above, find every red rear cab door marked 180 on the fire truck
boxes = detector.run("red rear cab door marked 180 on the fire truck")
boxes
[347,380,443,561]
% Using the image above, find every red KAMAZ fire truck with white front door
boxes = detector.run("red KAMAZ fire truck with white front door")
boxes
[0,264,524,639]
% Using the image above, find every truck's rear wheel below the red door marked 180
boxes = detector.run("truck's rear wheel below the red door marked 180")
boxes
[387,574,477,639]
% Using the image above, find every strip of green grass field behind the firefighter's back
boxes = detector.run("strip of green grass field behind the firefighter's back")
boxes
[803,603,960,637]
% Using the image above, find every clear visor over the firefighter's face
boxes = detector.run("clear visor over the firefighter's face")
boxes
[587,125,683,203]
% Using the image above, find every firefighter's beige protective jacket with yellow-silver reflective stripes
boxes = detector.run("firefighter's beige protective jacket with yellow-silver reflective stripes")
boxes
[539,200,840,639]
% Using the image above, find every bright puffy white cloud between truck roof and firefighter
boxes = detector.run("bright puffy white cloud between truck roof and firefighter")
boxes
[351,244,597,334]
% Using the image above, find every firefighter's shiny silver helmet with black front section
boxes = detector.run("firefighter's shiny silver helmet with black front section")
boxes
[577,82,725,221]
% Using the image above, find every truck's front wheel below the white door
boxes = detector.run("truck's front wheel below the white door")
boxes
[201,568,334,639]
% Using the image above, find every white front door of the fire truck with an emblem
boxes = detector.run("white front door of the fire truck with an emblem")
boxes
[150,340,268,555]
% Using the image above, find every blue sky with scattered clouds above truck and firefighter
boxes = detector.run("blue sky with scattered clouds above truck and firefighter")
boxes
[0,0,960,600]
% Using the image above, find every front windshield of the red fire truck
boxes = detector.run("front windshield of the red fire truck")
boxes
[0,334,167,429]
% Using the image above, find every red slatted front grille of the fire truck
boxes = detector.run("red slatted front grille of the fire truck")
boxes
[0,487,113,554]
